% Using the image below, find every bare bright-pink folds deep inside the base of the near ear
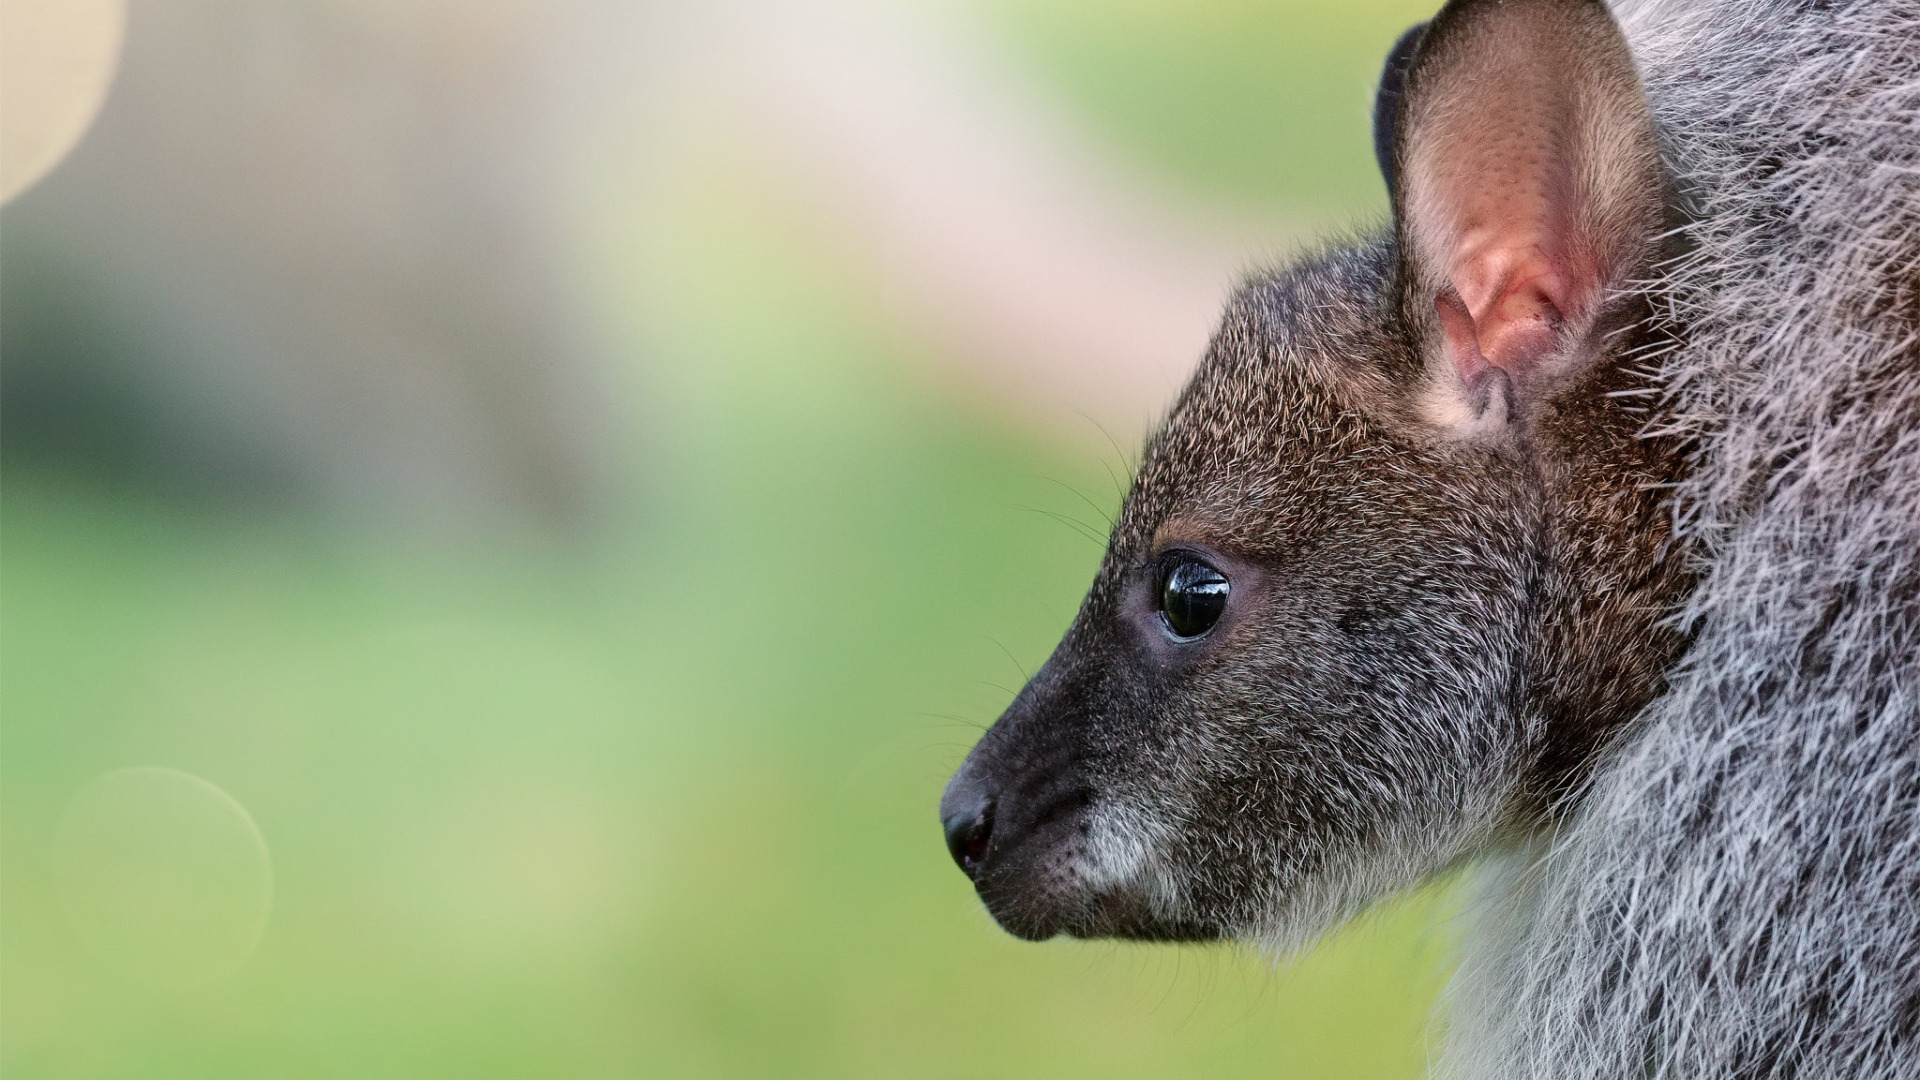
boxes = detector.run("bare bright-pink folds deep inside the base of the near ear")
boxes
[1436,236,1580,386]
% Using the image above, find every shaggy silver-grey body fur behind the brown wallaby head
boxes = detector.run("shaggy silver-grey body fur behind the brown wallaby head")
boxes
[1455,0,1920,1080]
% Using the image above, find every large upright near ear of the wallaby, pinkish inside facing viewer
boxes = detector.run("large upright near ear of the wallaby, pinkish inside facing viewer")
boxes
[1394,0,1668,436]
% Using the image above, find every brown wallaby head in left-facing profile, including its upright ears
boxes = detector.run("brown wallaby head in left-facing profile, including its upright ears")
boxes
[941,0,1690,942]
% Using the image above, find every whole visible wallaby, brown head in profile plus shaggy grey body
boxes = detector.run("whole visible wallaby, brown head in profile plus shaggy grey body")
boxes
[941,0,1920,1080]
